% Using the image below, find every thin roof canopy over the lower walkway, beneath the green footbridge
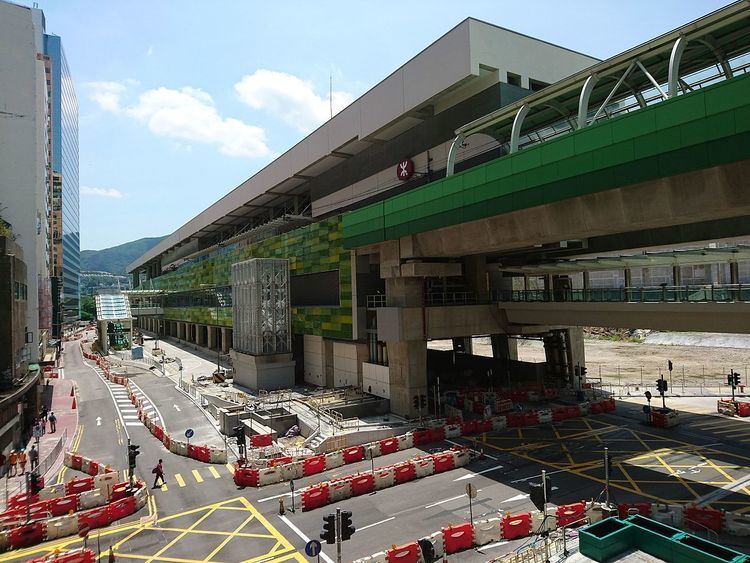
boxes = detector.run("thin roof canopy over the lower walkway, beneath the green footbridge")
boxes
[500,245,750,276]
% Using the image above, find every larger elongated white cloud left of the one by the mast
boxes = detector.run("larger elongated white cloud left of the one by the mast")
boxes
[86,82,272,158]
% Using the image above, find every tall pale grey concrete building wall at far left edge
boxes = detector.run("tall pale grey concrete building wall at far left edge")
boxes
[0,2,51,362]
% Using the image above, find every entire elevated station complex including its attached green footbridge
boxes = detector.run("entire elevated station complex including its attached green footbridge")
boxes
[128,1,750,416]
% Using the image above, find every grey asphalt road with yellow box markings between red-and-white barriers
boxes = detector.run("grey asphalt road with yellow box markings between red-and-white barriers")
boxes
[5,343,750,563]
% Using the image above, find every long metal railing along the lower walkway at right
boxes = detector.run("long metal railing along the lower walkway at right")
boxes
[492,284,750,303]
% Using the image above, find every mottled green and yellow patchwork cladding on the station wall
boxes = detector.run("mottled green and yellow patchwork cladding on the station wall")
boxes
[152,217,352,339]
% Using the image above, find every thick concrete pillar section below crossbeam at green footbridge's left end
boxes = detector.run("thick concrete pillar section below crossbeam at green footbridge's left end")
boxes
[387,340,429,418]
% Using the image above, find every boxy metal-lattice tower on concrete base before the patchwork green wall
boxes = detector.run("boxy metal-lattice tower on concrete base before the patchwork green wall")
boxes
[231,258,295,391]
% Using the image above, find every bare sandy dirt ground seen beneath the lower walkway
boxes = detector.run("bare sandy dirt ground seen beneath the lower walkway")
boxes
[430,338,750,385]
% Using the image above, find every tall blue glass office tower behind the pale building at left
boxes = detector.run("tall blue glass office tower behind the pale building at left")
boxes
[44,34,81,326]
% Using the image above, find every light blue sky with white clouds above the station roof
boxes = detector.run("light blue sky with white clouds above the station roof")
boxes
[25,0,728,249]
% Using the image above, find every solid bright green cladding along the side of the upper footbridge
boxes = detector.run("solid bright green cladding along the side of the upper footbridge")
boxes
[343,74,750,248]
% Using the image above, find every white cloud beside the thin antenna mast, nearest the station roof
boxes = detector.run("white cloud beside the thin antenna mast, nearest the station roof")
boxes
[234,69,354,132]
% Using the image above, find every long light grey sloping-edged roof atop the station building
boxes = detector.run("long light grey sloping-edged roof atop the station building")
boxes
[127,18,599,272]
